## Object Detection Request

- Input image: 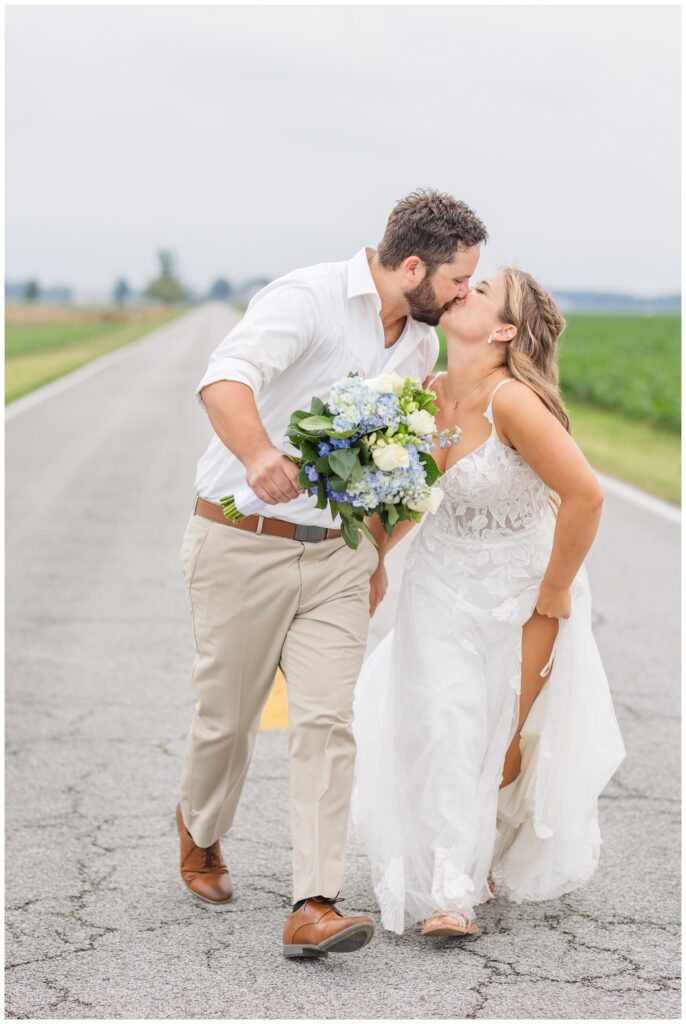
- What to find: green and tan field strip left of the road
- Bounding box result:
[5,305,182,402]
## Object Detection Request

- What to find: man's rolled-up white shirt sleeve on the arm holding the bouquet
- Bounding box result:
[196,279,324,402]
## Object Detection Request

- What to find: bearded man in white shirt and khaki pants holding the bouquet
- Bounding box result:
[176,190,486,956]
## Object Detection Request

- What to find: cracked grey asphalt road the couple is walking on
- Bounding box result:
[5,304,680,1019]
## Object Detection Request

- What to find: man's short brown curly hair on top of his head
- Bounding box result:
[378,188,488,274]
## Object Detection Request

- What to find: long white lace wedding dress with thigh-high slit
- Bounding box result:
[352,381,625,933]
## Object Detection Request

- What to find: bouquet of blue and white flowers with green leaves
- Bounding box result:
[221,373,461,548]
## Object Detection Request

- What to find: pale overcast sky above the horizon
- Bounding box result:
[6,6,680,294]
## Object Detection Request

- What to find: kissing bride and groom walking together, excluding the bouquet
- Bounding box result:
[176,190,625,957]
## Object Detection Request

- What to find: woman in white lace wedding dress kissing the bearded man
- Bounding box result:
[352,269,625,935]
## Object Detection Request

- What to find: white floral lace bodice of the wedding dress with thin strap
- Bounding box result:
[424,380,552,541]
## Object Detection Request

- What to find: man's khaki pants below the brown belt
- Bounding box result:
[181,515,378,900]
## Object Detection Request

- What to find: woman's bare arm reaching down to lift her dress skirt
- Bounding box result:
[494,381,603,618]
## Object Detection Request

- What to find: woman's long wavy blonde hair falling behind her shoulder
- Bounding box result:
[500,267,569,431]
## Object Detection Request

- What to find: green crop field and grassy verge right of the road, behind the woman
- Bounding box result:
[438,313,681,503]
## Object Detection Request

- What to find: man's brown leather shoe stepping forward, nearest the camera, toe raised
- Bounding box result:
[284,896,374,956]
